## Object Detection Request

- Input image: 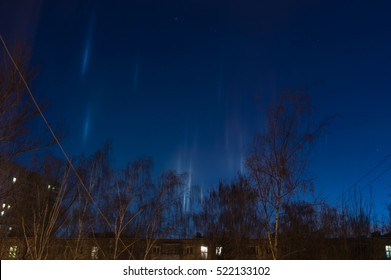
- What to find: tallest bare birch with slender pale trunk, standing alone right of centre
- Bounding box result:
[246,93,325,259]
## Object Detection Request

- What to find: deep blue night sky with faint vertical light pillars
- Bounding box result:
[0,0,391,217]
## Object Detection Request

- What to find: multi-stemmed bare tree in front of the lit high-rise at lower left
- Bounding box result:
[1,154,69,259]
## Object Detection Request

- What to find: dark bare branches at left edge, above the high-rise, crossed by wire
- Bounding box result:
[0,42,47,161]
